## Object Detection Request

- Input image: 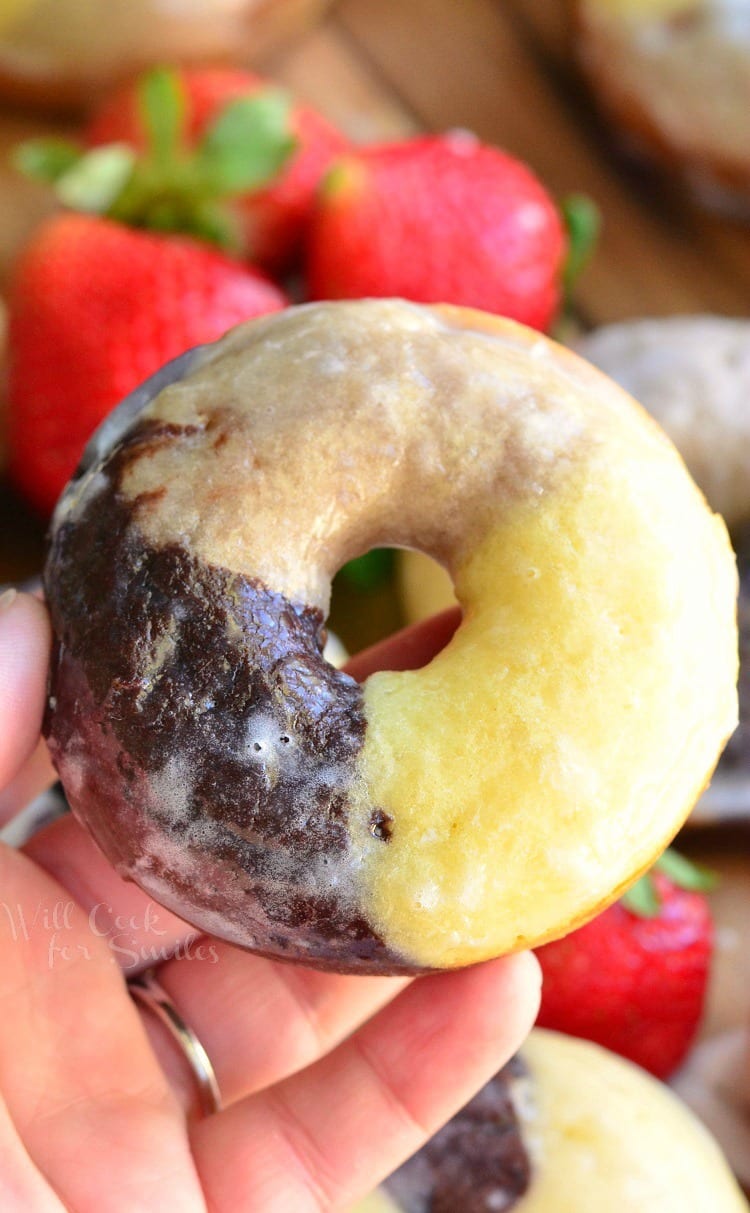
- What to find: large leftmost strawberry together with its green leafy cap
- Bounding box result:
[8,70,294,513]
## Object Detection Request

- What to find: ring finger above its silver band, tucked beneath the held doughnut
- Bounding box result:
[142,939,407,1106]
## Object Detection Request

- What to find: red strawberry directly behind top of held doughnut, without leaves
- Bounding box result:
[307,131,568,329]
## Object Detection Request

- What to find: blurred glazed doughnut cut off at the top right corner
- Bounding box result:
[572,0,750,216]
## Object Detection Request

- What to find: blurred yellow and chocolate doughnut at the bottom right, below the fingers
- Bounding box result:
[351,1029,748,1213]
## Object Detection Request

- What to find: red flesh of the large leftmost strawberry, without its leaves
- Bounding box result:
[8,215,286,513]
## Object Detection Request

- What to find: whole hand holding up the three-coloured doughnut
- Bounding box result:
[0,594,539,1213]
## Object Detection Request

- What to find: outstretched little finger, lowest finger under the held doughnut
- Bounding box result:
[193,955,540,1213]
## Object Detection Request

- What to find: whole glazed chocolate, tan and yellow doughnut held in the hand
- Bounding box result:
[45,300,737,973]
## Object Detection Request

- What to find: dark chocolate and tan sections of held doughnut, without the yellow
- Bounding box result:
[46,302,578,973]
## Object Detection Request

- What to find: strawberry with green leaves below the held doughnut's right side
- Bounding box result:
[536,850,712,1078]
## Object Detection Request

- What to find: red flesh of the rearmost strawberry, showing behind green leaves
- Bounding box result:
[86,68,348,269]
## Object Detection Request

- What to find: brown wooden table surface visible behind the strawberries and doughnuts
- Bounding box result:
[0,0,750,1164]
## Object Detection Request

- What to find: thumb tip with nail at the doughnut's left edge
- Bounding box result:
[0,590,51,787]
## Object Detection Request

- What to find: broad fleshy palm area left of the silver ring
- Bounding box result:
[0,847,205,1213]
